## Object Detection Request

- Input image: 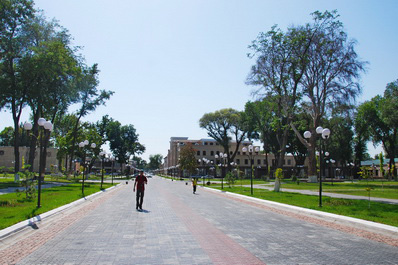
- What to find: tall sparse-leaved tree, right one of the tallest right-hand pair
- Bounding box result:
[291,11,366,176]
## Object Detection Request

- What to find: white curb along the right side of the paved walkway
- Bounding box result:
[202,187,398,235]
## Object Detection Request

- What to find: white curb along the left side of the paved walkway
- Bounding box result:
[0,183,122,240]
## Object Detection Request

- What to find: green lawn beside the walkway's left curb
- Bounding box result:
[0,183,116,229]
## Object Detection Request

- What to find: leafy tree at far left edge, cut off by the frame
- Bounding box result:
[0,0,34,173]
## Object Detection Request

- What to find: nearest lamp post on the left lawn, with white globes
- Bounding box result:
[23,118,53,208]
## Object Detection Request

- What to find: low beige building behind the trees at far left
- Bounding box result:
[0,146,58,173]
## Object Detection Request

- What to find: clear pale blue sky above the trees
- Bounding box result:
[0,0,398,159]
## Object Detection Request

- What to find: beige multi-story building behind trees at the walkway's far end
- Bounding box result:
[164,137,295,176]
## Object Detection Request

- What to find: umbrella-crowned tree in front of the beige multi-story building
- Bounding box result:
[199,108,248,172]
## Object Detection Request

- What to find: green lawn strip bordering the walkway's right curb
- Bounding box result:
[211,186,398,226]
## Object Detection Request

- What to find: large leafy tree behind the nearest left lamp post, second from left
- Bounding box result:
[20,14,80,171]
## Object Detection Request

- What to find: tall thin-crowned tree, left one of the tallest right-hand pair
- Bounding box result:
[246,20,313,167]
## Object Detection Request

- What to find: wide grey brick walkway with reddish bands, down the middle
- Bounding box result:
[0,175,398,264]
